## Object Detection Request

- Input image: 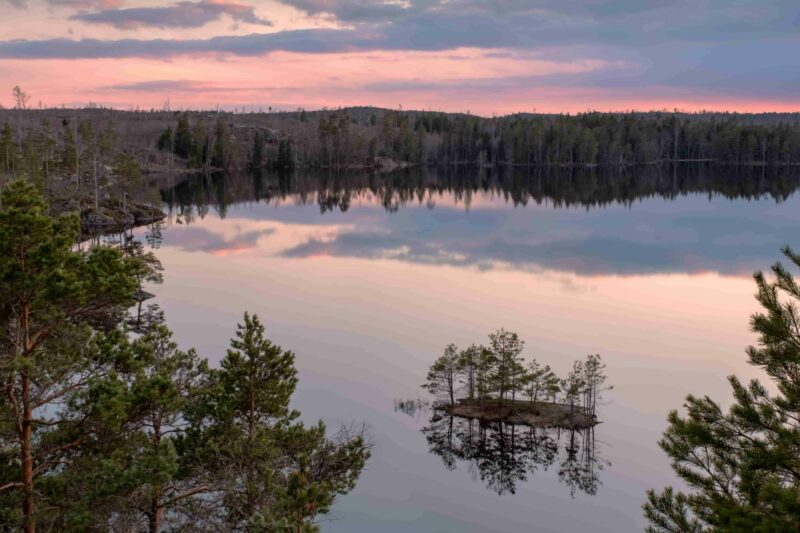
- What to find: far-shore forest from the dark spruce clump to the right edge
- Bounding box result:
[141,105,800,169]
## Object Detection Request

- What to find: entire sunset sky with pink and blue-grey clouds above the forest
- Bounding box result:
[0,0,800,116]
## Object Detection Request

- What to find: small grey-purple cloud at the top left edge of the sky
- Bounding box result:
[70,0,271,30]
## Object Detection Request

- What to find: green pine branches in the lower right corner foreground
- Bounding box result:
[644,248,800,533]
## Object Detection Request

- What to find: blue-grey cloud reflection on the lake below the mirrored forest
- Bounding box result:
[161,168,800,276]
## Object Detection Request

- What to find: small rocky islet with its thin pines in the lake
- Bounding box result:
[422,329,611,429]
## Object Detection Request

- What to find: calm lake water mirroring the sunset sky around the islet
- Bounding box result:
[142,169,800,533]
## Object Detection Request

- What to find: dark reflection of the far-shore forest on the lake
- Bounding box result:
[163,165,800,218]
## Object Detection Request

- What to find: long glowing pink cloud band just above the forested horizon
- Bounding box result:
[0,48,800,115]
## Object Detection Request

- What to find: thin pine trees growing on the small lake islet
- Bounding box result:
[423,329,608,419]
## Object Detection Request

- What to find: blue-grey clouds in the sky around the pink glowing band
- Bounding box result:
[0,0,800,103]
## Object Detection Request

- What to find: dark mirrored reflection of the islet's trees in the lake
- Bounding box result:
[422,413,609,498]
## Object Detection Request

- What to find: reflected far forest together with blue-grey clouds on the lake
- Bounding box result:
[156,166,800,276]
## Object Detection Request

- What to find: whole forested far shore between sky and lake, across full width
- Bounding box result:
[9,96,800,180]
